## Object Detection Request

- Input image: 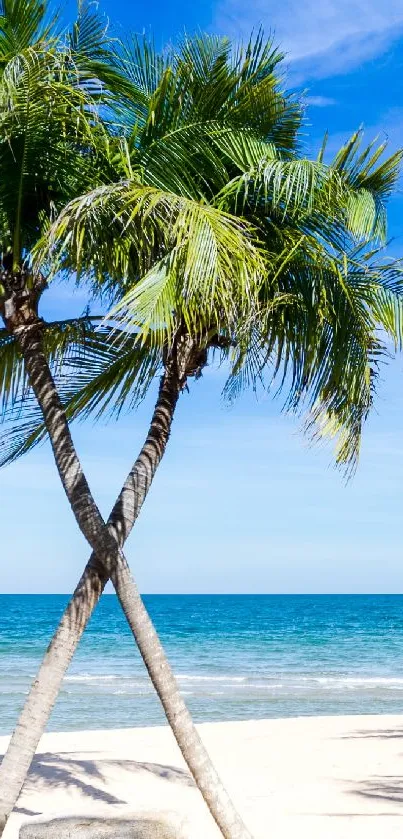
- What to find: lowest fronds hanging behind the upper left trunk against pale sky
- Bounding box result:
[0,319,162,466]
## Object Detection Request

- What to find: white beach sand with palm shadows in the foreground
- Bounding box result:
[0,715,403,839]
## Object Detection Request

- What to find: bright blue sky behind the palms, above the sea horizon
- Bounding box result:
[0,0,403,592]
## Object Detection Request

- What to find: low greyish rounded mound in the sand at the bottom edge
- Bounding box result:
[19,817,181,839]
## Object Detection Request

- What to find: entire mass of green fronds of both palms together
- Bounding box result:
[0,8,402,472]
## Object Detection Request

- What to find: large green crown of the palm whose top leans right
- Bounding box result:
[4,26,402,472]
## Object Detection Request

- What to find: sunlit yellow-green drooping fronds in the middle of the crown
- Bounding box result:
[38,181,265,343]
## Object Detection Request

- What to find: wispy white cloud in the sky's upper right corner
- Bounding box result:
[214,0,403,79]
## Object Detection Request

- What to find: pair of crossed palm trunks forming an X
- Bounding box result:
[0,320,251,839]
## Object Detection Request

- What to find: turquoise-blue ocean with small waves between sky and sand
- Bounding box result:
[0,595,403,734]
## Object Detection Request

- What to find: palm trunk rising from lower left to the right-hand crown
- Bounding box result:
[0,352,179,836]
